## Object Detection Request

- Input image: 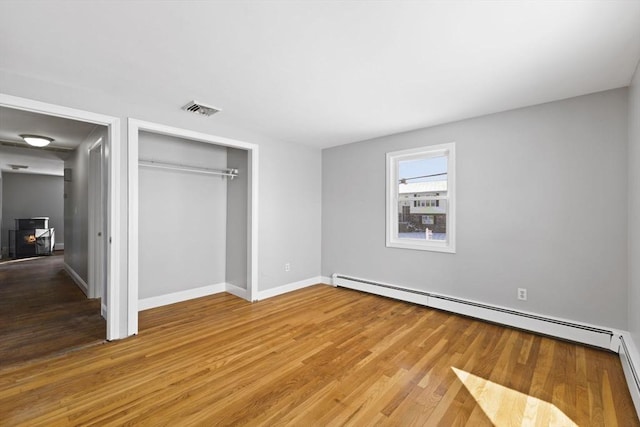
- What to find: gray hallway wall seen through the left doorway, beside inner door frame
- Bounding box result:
[64,126,107,282]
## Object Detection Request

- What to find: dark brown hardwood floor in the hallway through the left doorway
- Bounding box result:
[0,254,106,368]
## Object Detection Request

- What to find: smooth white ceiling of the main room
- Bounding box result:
[0,0,640,147]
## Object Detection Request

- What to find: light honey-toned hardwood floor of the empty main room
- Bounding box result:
[0,285,640,426]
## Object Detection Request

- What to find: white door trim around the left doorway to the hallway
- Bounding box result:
[0,93,126,340]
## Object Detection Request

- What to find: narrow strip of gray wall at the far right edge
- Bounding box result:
[628,68,640,348]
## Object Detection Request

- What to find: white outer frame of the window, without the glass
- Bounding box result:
[386,142,456,253]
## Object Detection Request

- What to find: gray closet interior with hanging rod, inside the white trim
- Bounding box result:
[138,131,248,301]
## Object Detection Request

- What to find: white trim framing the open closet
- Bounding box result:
[127,118,258,335]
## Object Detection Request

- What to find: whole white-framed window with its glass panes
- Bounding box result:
[387,143,455,253]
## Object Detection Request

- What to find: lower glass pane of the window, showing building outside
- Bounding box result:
[398,199,447,240]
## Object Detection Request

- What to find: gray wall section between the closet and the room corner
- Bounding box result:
[258,139,322,290]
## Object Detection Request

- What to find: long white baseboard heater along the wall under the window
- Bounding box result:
[331,274,619,352]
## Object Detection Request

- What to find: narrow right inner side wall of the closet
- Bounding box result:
[226,148,249,289]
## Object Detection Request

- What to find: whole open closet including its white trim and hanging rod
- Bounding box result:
[128,119,258,335]
